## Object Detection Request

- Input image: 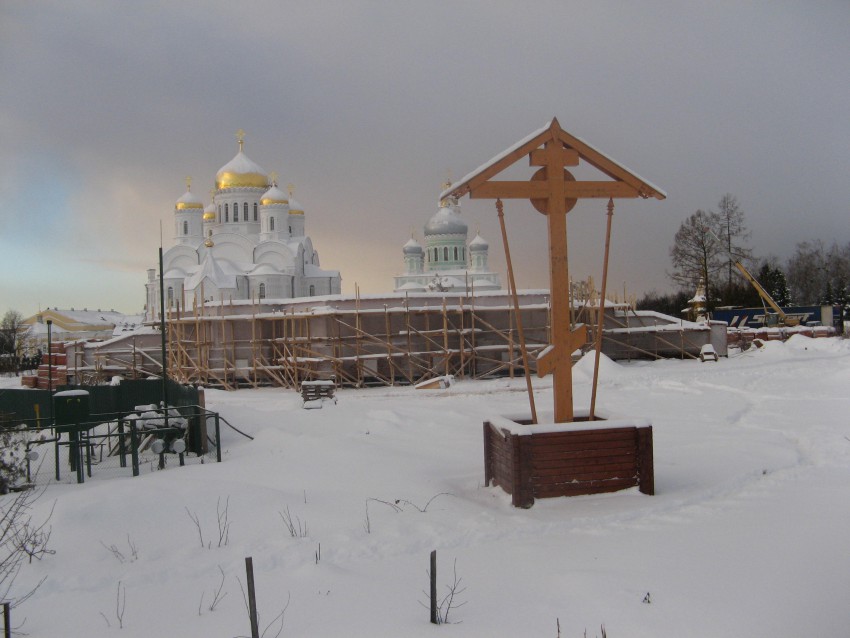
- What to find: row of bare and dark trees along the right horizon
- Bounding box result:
[638,193,850,316]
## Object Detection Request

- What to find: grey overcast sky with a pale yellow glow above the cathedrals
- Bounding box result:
[0,0,850,315]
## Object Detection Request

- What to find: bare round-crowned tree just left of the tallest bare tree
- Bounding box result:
[670,210,725,309]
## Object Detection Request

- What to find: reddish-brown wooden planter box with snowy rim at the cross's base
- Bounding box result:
[484,419,655,508]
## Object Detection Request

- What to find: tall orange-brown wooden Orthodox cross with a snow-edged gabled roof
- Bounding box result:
[440,119,667,423]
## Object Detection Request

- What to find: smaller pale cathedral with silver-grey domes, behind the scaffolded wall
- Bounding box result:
[395,183,502,294]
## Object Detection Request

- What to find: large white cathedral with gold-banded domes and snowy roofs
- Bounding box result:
[145,131,341,321]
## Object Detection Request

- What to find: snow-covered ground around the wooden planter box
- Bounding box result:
[3,336,850,638]
